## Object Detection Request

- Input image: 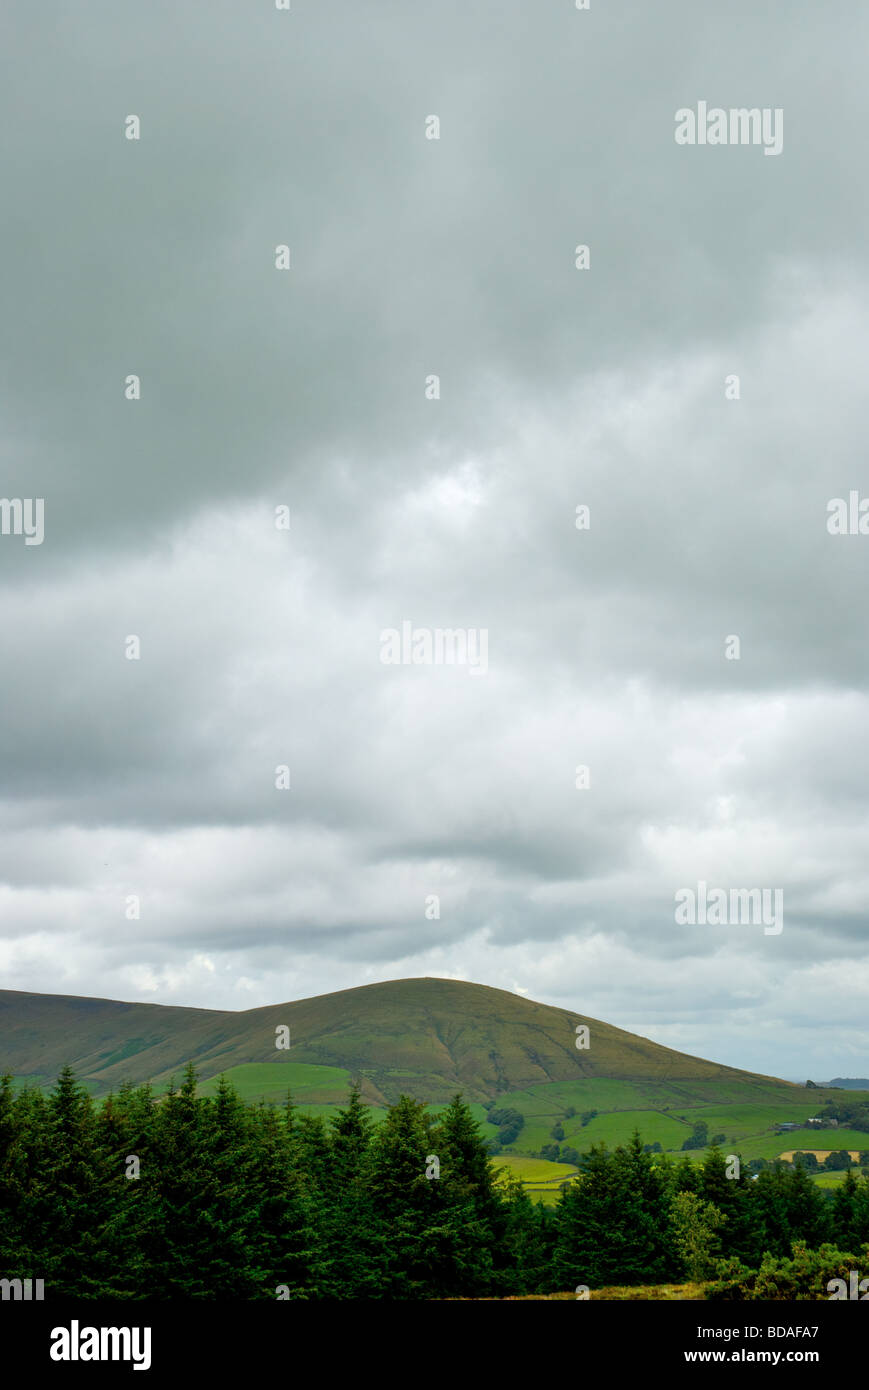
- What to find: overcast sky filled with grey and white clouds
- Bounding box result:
[0,0,869,1080]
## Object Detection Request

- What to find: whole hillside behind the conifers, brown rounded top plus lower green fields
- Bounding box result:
[0,979,869,1201]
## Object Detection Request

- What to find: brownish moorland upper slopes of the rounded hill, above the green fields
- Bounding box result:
[0,977,800,1104]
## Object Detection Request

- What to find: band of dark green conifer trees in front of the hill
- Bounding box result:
[0,1066,869,1300]
